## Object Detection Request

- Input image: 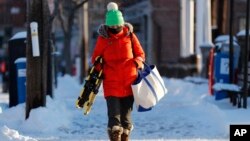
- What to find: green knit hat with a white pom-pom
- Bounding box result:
[105,2,124,26]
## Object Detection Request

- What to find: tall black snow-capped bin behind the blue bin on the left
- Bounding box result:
[8,31,27,107]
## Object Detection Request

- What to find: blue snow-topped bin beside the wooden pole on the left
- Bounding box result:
[15,57,26,104]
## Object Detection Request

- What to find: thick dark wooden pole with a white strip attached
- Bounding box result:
[26,0,50,119]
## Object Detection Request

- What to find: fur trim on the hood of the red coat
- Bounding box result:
[97,23,133,38]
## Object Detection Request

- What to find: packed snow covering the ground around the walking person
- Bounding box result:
[0,75,250,141]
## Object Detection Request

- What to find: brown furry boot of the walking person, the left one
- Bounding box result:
[108,126,123,141]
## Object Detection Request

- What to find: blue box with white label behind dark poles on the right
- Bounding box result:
[214,41,240,100]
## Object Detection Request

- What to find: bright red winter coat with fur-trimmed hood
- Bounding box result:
[92,23,145,97]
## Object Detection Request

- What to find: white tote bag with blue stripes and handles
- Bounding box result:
[131,62,167,112]
